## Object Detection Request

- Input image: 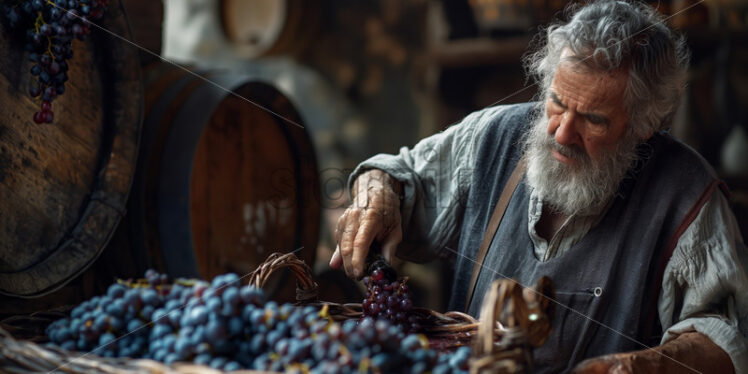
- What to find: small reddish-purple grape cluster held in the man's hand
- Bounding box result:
[361,268,421,332]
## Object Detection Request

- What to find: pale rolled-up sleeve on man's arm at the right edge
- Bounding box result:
[659,191,748,373]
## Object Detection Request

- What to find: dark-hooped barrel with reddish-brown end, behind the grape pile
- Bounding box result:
[128,64,320,288]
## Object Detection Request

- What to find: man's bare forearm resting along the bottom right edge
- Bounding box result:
[572,332,734,374]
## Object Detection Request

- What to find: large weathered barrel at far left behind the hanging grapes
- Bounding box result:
[0,0,142,298]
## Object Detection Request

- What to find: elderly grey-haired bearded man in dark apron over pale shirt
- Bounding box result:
[330,1,748,373]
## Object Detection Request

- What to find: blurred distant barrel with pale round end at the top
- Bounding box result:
[220,0,321,58]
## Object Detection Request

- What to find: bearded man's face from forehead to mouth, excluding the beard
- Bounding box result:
[545,62,628,167]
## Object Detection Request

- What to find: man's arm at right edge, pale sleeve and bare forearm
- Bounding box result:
[579,190,748,374]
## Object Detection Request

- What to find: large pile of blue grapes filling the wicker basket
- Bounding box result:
[47,271,470,374]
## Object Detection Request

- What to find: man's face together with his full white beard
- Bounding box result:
[525,57,640,215]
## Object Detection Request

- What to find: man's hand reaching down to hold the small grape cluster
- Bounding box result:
[330,169,403,279]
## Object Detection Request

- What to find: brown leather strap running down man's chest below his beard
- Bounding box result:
[465,158,525,311]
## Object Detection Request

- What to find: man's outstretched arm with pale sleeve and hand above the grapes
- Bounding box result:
[330,107,503,278]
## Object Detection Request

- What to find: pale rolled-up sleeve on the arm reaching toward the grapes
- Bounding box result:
[348,107,504,262]
